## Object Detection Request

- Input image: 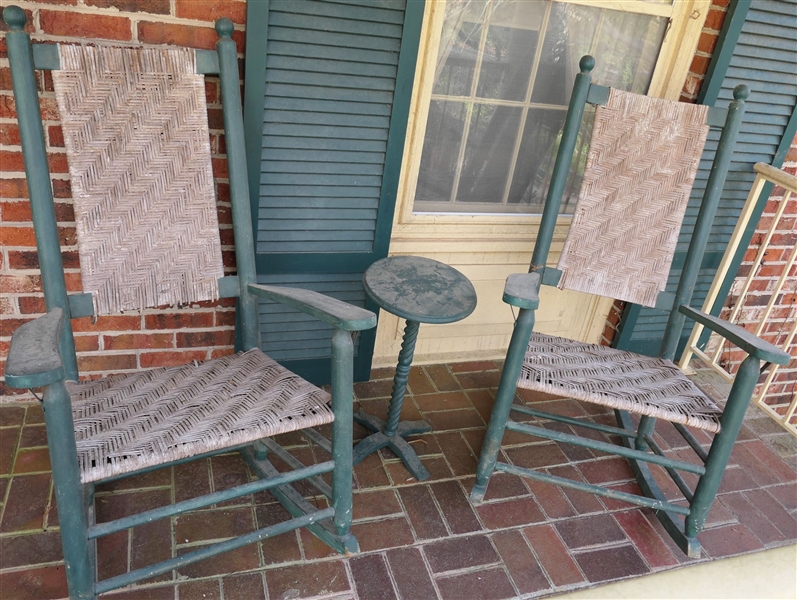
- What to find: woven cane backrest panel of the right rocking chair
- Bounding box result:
[558,89,708,307]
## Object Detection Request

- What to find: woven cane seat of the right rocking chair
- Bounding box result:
[518,333,722,433]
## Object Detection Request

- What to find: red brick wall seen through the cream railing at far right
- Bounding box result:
[712,136,797,412]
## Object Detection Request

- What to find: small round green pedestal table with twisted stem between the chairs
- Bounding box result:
[354,256,476,481]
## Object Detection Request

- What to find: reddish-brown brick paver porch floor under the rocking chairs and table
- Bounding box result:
[0,361,797,600]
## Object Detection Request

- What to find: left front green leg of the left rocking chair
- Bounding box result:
[44,381,95,599]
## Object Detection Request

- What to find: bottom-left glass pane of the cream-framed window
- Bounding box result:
[415,100,467,202]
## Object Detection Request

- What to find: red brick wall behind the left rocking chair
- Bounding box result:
[0,0,246,400]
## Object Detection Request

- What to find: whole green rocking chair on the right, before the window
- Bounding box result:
[471,56,789,557]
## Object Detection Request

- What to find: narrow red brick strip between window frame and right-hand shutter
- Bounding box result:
[601,0,731,346]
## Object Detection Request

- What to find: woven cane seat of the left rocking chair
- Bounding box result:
[63,349,333,483]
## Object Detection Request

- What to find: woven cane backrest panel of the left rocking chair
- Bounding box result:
[53,45,223,314]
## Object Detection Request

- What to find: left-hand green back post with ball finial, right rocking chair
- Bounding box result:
[529,55,595,272]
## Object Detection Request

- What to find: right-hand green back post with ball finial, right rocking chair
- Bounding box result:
[659,84,750,360]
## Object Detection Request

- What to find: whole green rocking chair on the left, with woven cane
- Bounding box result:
[3,6,376,598]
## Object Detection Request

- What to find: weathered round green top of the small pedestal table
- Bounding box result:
[363,256,476,323]
